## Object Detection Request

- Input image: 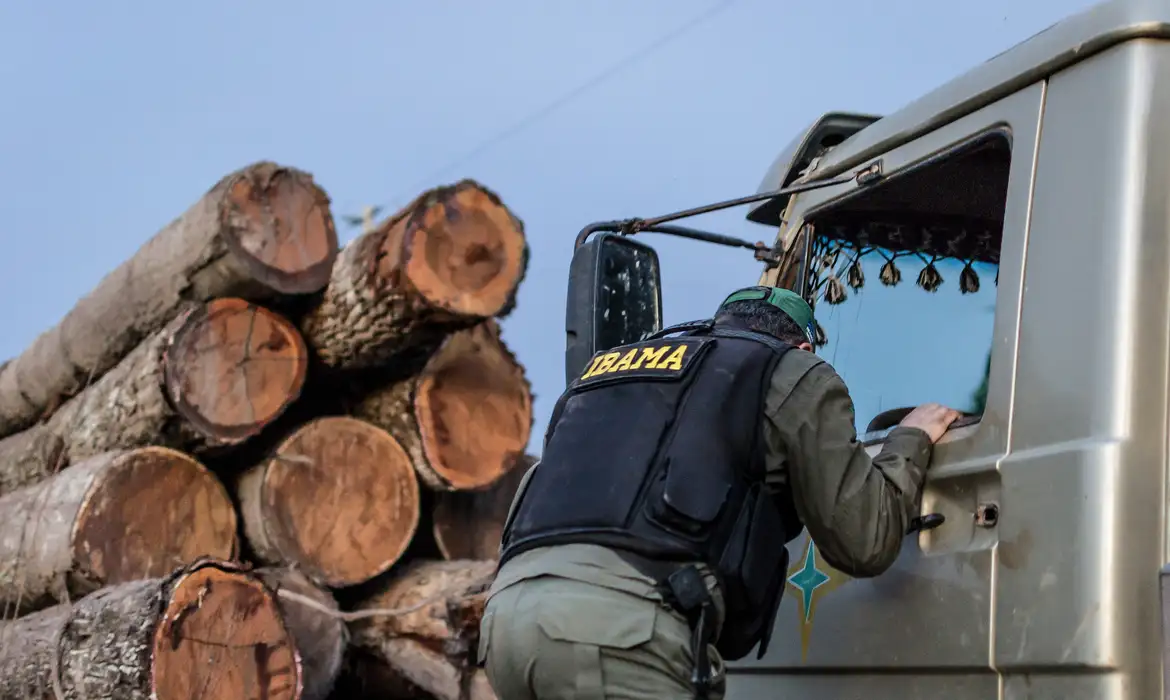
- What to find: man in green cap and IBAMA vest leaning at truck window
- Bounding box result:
[479,287,958,700]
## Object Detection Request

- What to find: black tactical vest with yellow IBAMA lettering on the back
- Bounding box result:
[500,322,801,659]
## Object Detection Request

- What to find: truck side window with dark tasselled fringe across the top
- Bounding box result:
[805,131,1011,433]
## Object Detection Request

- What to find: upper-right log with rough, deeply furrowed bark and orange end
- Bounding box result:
[301,180,528,369]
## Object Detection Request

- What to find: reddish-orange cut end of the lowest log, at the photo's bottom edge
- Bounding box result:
[151,567,302,700]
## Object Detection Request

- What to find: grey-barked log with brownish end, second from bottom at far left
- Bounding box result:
[0,447,236,615]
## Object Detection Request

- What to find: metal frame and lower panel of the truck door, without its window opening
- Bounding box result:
[731,84,1044,683]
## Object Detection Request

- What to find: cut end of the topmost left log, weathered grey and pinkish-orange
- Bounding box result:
[220,163,338,294]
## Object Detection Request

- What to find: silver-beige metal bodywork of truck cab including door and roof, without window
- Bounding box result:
[728,0,1170,700]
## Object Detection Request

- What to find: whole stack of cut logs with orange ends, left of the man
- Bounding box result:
[0,162,532,700]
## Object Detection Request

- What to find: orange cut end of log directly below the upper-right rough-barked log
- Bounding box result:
[414,322,532,490]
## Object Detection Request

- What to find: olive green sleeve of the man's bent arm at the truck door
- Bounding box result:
[764,354,932,578]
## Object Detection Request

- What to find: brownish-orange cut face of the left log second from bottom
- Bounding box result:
[73,447,236,584]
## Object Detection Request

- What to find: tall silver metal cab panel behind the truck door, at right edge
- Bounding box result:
[993,40,1170,699]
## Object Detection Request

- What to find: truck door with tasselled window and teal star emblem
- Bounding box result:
[728,83,1045,700]
